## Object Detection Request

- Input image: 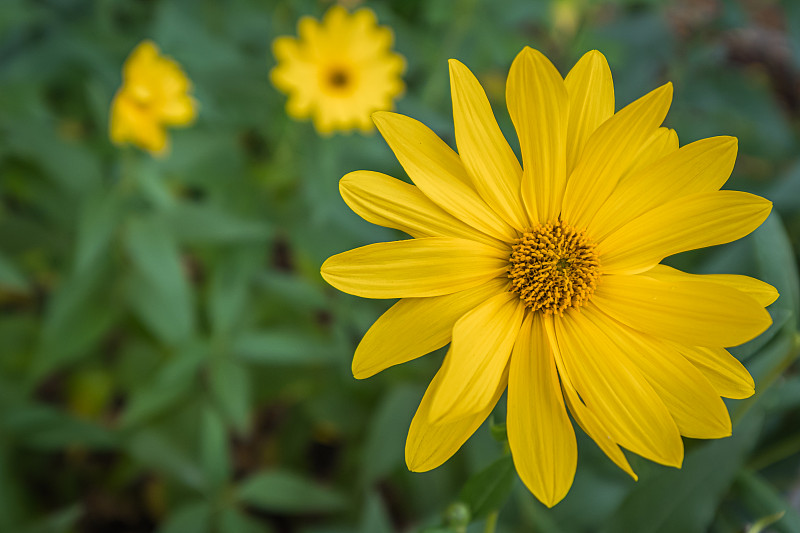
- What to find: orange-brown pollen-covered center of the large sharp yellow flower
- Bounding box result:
[508,220,600,315]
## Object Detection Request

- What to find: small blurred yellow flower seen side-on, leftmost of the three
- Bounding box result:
[110,41,197,155]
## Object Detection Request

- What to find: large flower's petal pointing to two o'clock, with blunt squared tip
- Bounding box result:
[589,137,736,240]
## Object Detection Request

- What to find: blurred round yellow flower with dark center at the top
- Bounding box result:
[270,6,405,134]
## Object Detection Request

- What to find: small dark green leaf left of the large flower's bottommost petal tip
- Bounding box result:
[458,455,516,520]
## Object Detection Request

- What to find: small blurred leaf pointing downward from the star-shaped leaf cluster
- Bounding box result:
[208,356,252,434]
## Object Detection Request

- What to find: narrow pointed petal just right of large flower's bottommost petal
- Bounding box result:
[542,315,639,479]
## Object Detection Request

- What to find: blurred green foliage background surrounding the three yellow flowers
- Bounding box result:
[0,0,800,533]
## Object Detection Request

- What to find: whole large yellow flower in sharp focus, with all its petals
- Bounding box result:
[322,48,777,506]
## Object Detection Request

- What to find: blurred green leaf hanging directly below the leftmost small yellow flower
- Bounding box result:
[125,216,195,344]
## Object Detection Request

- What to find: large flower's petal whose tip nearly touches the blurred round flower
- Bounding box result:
[372,111,516,241]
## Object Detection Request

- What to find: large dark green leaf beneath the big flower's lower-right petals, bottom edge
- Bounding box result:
[602,411,763,533]
